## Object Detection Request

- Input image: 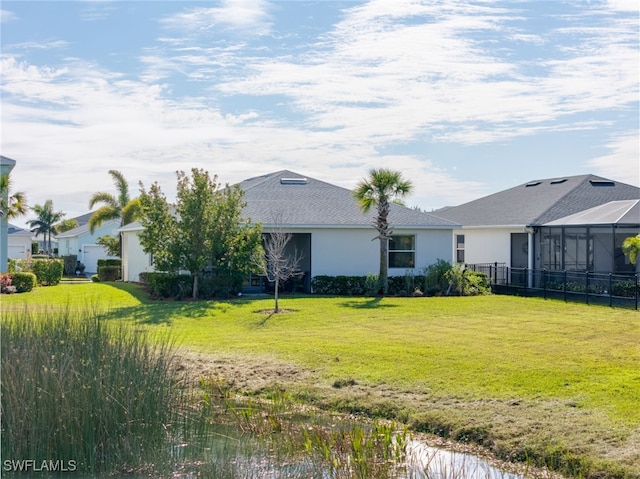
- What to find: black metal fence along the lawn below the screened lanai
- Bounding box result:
[467,263,640,310]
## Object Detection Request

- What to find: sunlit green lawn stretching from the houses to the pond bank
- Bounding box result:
[0,283,640,477]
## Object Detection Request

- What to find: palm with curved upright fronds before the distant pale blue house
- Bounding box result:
[89,170,140,257]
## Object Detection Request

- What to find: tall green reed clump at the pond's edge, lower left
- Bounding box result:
[0,310,188,473]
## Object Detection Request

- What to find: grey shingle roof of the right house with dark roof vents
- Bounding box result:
[437,175,640,226]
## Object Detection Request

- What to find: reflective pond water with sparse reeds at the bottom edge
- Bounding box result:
[159,408,524,479]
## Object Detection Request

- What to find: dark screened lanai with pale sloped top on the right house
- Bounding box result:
[536,200,640,274]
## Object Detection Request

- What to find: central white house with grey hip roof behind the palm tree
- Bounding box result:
[120,170,459,290]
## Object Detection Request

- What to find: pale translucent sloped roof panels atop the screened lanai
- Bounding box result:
[544,199,640,226]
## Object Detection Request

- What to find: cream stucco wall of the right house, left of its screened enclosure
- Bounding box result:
[453,227,525,267]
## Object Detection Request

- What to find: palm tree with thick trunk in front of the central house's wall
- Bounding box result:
[353,168,413,294]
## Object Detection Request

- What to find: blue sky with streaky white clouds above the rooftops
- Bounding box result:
[0,0,640,229]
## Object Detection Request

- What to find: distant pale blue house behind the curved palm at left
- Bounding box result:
[58,215,120,274]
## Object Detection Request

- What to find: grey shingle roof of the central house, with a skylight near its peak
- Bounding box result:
[238,170,459,229]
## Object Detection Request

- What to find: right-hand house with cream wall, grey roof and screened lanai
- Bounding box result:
[435,175,640,273]
